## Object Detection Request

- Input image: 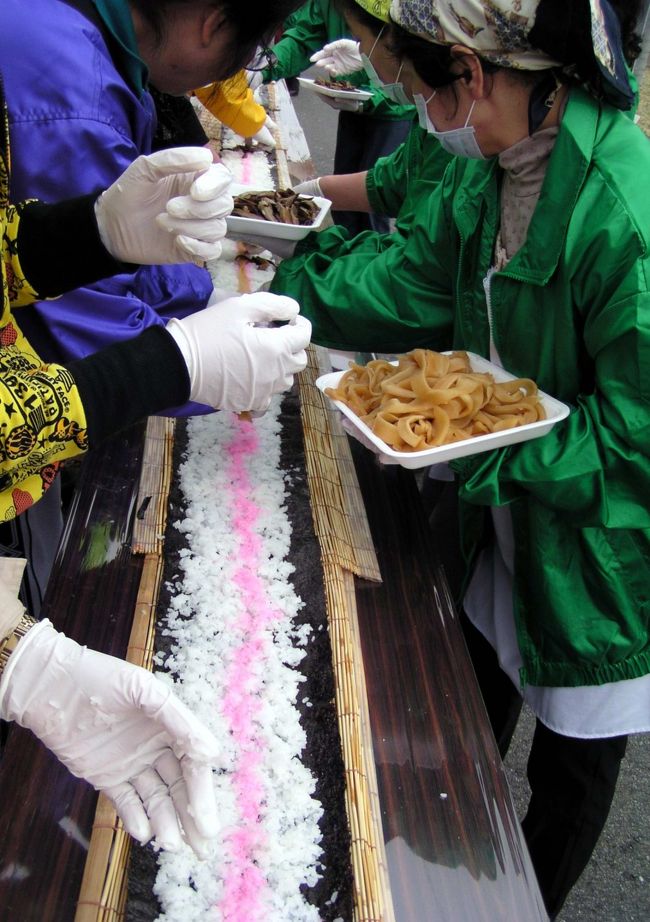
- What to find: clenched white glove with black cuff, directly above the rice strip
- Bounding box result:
[167,292,311,413]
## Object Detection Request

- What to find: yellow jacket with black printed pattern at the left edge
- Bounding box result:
[0,90,87,520]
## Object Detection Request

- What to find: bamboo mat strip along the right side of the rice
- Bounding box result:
[300,346,395,922]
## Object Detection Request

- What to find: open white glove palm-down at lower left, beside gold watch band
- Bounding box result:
[0,621,219,857]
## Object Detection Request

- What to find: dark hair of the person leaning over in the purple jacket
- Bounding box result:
[130,0,301,80]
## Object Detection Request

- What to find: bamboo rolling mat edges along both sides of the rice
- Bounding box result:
[75,93,395,922]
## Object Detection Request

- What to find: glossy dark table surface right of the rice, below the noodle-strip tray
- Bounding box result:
[346,446,547,922]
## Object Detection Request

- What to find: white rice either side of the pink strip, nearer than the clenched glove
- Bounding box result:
[154,397,321,922]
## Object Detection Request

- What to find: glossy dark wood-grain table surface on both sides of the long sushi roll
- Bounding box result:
[0,418,546,922]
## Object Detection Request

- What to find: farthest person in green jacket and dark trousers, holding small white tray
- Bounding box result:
[253,0,414,234]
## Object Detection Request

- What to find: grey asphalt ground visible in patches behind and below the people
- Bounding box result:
[293,71,650,922]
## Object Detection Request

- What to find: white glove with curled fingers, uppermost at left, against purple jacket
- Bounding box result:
[95,147,233,265]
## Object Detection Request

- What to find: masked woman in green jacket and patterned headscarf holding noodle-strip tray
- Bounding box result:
[275,0,650,917]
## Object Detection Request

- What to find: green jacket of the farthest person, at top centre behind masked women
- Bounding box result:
[262,0,408,121]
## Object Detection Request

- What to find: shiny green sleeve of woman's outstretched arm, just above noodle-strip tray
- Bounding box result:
[271,180,453,352]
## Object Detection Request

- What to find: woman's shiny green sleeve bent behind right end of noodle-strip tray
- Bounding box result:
[451,285,650,529]
